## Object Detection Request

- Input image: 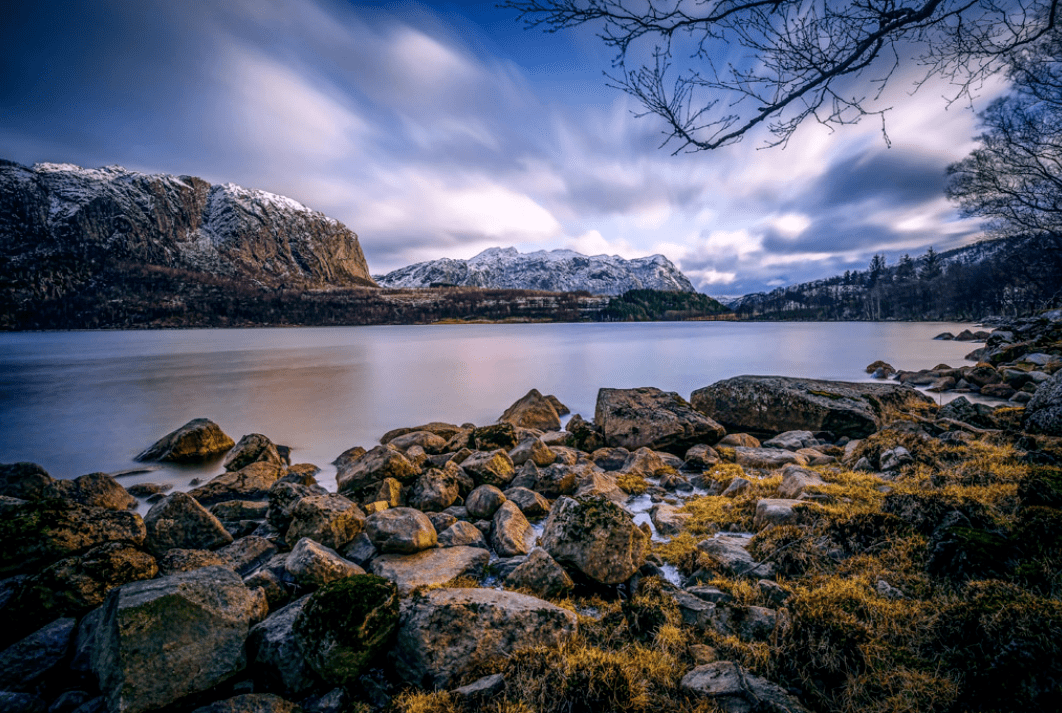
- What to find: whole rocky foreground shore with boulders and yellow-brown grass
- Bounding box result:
[0,315,1062,713]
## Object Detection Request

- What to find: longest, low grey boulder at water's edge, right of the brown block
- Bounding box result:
[690,376,933,438]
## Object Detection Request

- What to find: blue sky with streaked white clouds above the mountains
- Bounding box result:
[0,0,1001,296]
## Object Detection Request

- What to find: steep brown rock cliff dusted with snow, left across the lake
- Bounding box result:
[0,162,373,299]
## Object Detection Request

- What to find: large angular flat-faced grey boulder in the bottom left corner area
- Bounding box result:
[92,566,266,713]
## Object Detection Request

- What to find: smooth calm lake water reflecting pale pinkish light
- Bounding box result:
[0,322,976,497]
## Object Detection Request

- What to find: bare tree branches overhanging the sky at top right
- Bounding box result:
[501,0,1062,153]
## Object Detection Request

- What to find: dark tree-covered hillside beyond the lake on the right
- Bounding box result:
[735,235,1062,321]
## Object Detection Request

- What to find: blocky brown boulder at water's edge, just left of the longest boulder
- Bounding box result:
[594,387,726,455]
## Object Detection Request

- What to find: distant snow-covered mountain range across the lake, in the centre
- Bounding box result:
[374,248,696,294]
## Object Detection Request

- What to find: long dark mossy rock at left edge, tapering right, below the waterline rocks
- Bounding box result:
[0,499,147,575]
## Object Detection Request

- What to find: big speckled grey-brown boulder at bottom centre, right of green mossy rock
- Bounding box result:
[394,589,577,689]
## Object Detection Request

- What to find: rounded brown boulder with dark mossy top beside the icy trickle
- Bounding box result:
[542,497,649,584]
